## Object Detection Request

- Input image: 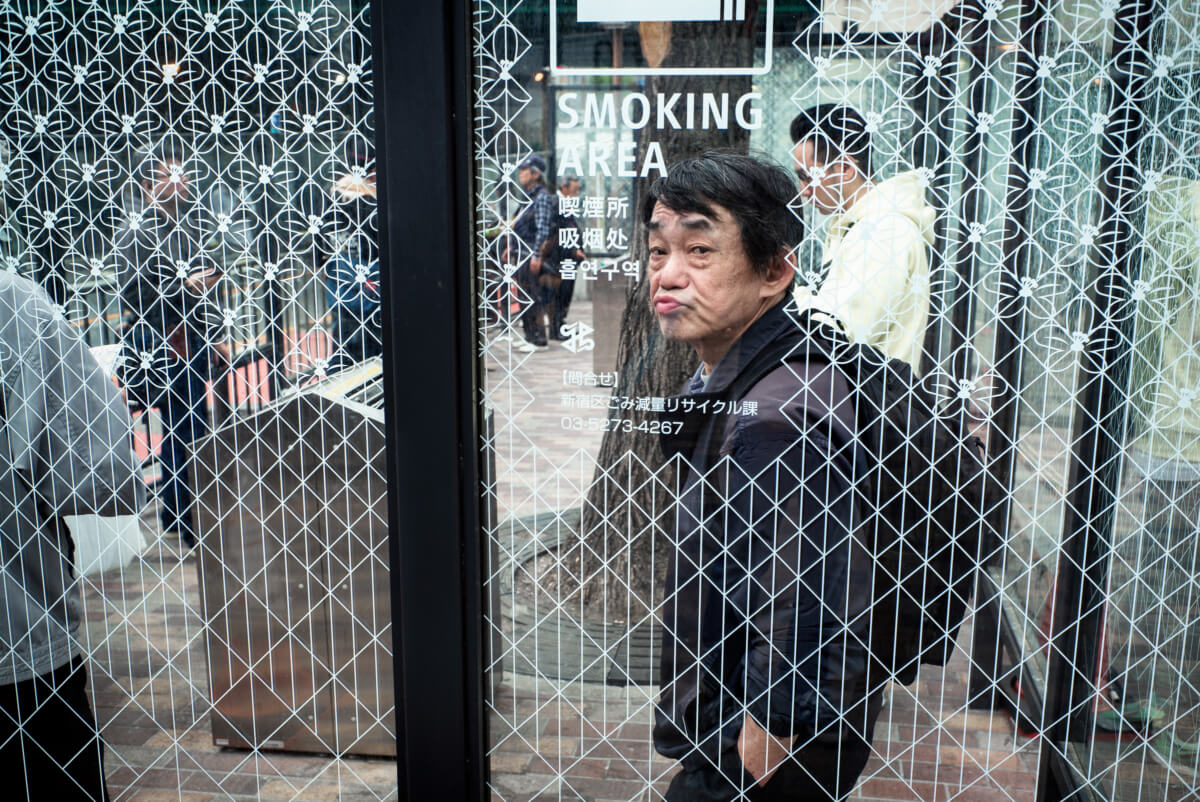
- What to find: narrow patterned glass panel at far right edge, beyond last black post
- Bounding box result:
[1084,2,1200,800]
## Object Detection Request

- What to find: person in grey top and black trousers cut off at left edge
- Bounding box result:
[0,267,145,800]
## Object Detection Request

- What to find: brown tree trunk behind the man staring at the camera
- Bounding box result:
[573,17,757,623]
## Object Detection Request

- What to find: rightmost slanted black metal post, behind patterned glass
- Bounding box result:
[1043,0,1157,768]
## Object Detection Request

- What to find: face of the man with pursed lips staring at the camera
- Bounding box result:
[649,203,778,365]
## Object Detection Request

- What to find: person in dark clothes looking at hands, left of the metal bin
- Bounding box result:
[119,145,229,549]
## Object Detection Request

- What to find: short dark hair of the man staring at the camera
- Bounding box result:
[642,152,804,275]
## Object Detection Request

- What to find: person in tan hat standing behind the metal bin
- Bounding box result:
[324,145,383,367]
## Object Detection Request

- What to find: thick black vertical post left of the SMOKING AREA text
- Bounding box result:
[371,0,486,802]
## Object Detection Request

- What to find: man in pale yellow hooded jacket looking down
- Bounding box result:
[791,103,936,373]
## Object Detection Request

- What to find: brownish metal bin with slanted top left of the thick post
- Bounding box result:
[191,359,396,755]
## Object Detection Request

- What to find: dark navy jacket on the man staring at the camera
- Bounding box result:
[654,301,871,765]
